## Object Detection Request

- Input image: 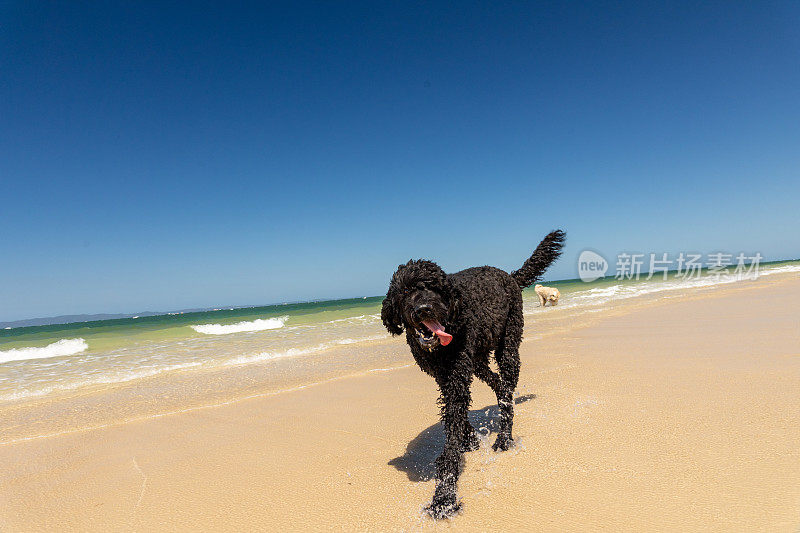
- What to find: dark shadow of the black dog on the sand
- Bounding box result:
[389,394,536,481]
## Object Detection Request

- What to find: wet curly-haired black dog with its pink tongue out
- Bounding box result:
[381,230,565,519]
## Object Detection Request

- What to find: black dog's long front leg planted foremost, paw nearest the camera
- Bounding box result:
[426,356,472,519]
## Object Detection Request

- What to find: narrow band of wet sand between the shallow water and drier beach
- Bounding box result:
[0,272,797,446]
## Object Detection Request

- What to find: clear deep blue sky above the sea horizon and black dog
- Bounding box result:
[0,2,800,320]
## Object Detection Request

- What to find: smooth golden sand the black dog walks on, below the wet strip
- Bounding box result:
[0,274,800,531]
